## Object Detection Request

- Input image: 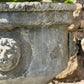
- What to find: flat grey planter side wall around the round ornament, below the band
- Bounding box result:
[0,25,68,84]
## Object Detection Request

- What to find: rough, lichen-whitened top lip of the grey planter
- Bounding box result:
[0,2,76,12]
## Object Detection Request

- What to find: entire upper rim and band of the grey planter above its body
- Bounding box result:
[0,2,76,29]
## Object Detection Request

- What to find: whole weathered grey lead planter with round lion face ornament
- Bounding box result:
[0,2,75,84]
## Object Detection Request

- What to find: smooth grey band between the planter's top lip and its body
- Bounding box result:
[0,11,73,30]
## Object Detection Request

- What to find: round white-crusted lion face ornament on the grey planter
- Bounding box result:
[0,38,20,71]
